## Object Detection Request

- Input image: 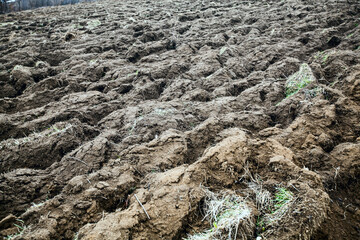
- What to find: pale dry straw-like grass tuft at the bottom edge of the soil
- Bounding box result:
[185,189,254,240]
